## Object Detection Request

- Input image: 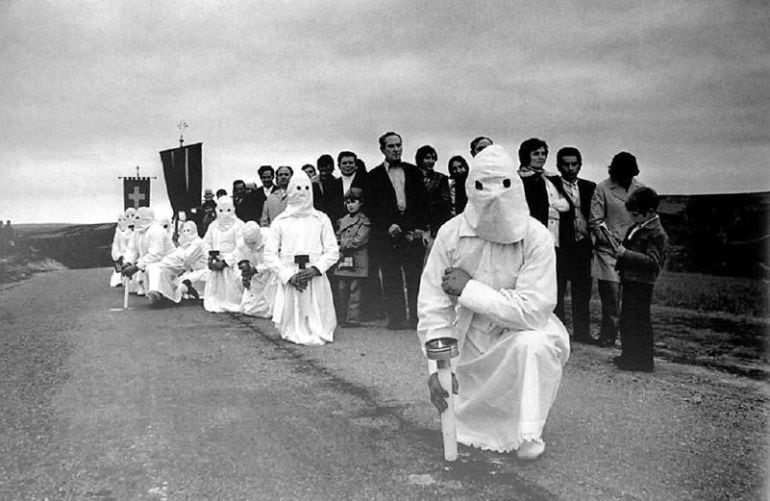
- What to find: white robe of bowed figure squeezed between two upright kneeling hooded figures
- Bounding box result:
[235,228,278,318]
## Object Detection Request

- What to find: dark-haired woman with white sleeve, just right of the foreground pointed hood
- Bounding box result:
[518,137,570,240]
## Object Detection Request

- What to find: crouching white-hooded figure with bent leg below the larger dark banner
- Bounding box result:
[147,221,208,303]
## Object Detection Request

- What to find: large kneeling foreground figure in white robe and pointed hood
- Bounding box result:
[417,145,570,460]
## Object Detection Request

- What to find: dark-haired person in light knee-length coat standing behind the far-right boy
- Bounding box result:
[588,151,643,346]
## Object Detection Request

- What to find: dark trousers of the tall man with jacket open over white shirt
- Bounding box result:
[377,238,425,325]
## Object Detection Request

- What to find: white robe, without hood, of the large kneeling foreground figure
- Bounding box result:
[417,215,570,452]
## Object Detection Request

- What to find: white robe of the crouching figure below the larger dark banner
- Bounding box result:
[146,237,209,303]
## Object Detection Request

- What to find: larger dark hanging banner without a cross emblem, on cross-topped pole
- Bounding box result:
[160,143,203,216]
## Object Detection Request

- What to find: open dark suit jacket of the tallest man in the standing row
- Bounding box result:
[366,162,428,234]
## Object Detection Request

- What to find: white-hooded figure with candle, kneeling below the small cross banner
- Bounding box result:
[123,207,176,296]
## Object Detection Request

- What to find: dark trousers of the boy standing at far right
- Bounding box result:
[620,282,653,369]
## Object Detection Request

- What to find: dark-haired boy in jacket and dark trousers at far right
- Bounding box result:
[614,187,668,372]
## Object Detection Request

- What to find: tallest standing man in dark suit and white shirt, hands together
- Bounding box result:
[365,132,428,330]
